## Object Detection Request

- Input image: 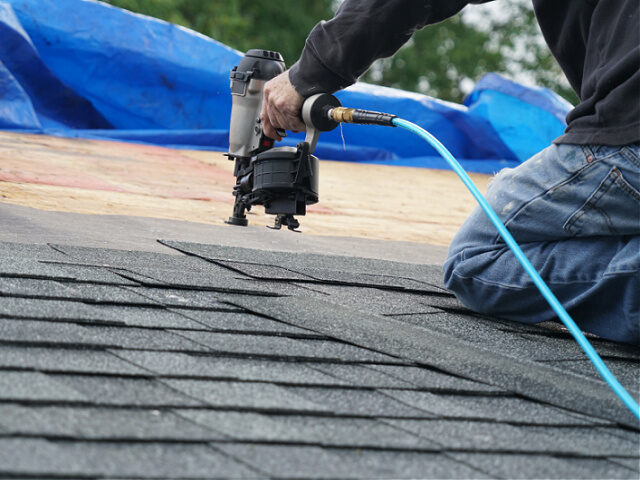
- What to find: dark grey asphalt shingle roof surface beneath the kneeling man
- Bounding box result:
[0,242,640,478]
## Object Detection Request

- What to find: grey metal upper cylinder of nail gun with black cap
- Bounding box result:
[229,49,285,158]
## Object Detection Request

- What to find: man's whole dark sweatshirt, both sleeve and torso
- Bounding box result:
[289,0,640,145]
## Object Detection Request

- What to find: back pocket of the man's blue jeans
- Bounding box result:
[563,167,640,236]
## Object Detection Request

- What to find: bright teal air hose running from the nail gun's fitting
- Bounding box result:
[390,116,640,420]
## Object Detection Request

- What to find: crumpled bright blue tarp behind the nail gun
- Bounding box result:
[0,0,571,173]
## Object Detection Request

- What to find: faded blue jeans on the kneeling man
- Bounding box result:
[444,143,640,344]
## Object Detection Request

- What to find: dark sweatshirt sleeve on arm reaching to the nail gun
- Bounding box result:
[289,0,487,97]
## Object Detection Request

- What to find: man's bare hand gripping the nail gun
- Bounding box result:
[260,70,306,140]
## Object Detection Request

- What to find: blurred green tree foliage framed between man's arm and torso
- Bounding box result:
[365,0,578,104]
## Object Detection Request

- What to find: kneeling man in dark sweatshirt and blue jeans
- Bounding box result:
[262,0,640,344]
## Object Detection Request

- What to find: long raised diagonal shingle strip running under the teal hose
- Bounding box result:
[228,297,638,428]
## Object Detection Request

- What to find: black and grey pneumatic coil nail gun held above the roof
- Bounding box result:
[226,50,340,230]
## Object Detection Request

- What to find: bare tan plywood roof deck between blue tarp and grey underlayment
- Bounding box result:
[0,132,490,246]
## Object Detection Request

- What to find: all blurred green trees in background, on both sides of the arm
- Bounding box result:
[106,0,577,104]
